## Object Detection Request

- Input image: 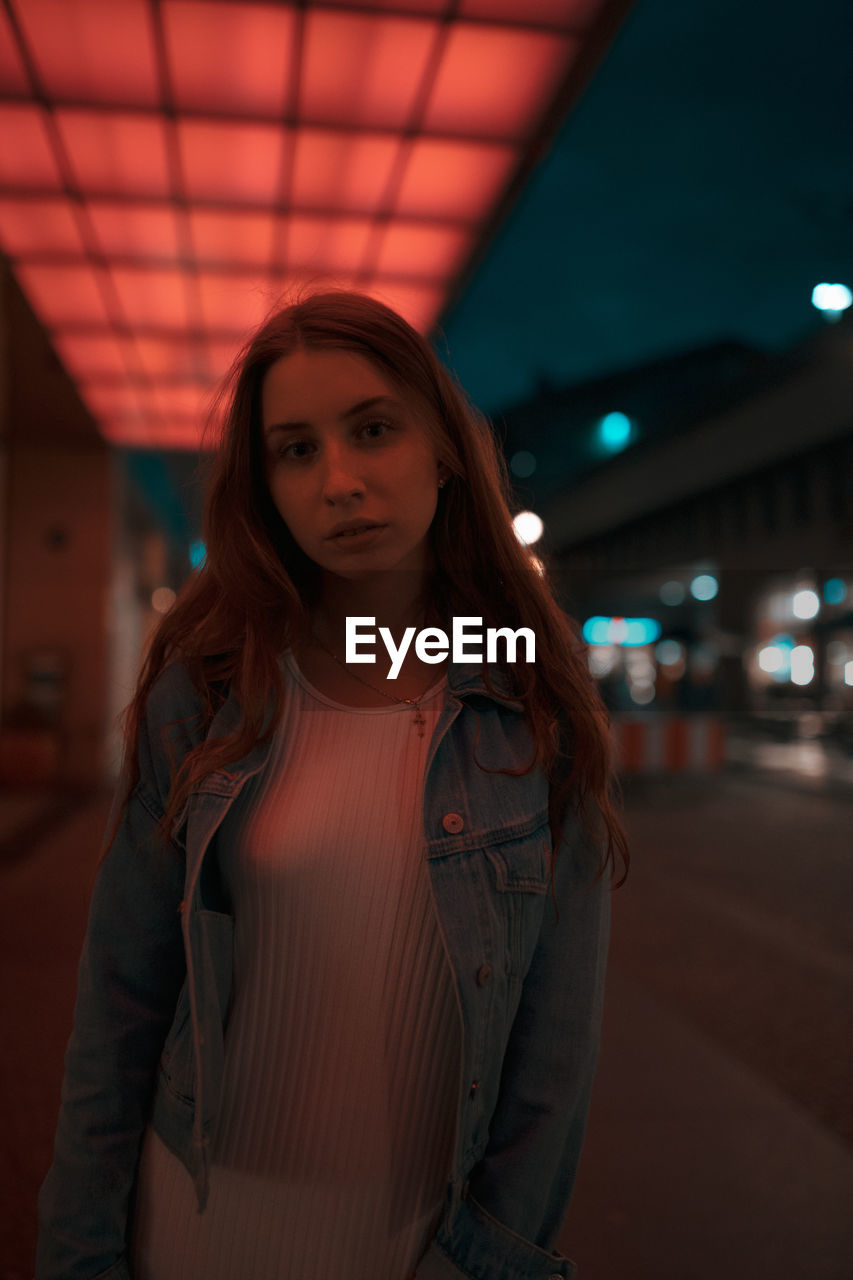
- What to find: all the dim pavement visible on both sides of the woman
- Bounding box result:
[0,756,853,1280]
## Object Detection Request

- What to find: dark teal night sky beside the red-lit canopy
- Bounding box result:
[437,0,853,412]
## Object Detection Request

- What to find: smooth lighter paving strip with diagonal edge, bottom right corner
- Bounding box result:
[557,965,853,1280]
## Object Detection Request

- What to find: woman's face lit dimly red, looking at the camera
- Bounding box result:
[261,348,439,579]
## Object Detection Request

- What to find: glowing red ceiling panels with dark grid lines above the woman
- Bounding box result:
[0,0,606,448]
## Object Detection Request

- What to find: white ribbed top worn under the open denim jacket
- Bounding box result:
[131,652,460,1280]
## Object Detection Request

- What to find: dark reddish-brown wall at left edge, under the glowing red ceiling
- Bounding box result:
[0,262,114,785]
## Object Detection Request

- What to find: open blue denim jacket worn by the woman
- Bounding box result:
[36,662,610,1280]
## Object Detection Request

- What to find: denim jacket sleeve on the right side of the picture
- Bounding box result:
[418,817,610,1280]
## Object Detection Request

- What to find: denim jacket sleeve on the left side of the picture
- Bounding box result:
[36,670,192,1280]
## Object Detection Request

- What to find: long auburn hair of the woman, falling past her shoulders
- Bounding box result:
[105,291,629,886]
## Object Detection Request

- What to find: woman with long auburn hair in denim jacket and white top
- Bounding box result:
[37,292,628,1280]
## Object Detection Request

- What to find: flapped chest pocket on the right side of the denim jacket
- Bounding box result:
[483,822,549,980]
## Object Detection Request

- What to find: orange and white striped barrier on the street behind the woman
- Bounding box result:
[611,716,726,773]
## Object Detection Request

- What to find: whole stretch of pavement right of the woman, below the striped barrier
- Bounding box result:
[558,771,853,1280]
